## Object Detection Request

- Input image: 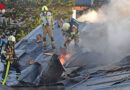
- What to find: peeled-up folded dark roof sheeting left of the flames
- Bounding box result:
[12,54,65,87]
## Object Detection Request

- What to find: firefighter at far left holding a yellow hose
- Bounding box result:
[1,36,21,85]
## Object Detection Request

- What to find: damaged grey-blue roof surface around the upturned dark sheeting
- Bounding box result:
[1,23,130,90]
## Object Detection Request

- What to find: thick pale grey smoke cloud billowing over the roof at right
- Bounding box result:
[78,0,130,63]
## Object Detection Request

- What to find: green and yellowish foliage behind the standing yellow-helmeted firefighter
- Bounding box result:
[2,0,75,41]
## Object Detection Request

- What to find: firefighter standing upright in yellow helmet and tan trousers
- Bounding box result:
[40,6,55,50]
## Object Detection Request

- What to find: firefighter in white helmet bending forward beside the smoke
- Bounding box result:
[62,20,80,48]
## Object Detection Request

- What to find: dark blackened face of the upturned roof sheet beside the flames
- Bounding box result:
[40,54,64,85]
